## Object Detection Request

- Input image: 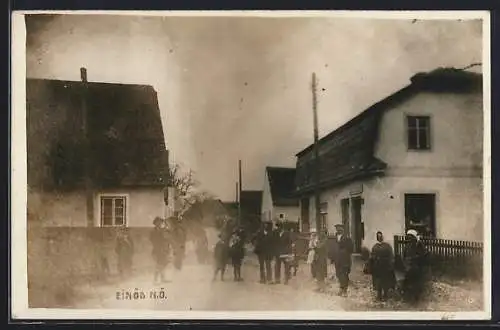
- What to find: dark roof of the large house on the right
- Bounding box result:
[295,68,482,195]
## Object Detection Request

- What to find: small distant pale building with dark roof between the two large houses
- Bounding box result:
[261,166,300,223]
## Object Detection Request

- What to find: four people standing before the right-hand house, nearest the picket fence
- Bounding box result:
[307,224,428,303]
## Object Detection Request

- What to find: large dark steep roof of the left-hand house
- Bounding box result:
[26,79,168,189]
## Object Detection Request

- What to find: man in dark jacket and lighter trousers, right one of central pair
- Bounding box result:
[273,222,292,284]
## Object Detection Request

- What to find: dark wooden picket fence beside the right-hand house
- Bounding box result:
[394,235,483,278]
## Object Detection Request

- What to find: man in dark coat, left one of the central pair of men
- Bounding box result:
[254,222,273,284]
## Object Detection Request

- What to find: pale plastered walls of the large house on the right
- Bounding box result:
[309,89,483,246]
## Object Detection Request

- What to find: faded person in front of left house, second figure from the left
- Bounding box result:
[149,217,170,283]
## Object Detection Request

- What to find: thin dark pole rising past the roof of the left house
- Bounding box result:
[80,68,94,227]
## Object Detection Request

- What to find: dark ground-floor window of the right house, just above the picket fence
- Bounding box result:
[405,194,436,237]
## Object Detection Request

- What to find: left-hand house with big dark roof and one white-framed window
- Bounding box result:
[26,79,169,227]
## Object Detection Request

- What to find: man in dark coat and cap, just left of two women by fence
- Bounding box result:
[333,224,353,297]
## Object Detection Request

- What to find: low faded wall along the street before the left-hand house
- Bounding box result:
[27,227,209,307]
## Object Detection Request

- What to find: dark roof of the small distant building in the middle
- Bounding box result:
[266,166,299,206]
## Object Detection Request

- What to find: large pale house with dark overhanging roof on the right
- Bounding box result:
[296,68,483,252]
